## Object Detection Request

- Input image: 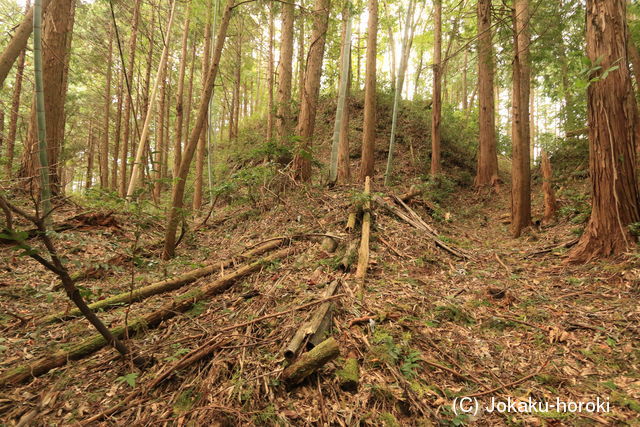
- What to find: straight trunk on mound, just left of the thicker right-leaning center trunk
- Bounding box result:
[276,2,296,145]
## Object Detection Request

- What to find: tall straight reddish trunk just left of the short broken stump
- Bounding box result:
[511,0,531,237]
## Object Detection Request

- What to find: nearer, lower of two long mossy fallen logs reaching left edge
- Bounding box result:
[0,247,297,386]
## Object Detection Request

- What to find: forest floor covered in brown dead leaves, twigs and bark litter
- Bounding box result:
[0,176,640,426]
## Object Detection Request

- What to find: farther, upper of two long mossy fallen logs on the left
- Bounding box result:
[39,239,285,324]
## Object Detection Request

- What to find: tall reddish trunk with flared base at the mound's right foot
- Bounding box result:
[475,0,499,187]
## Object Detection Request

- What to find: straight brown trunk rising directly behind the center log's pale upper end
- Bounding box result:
[358,0,378,182]
